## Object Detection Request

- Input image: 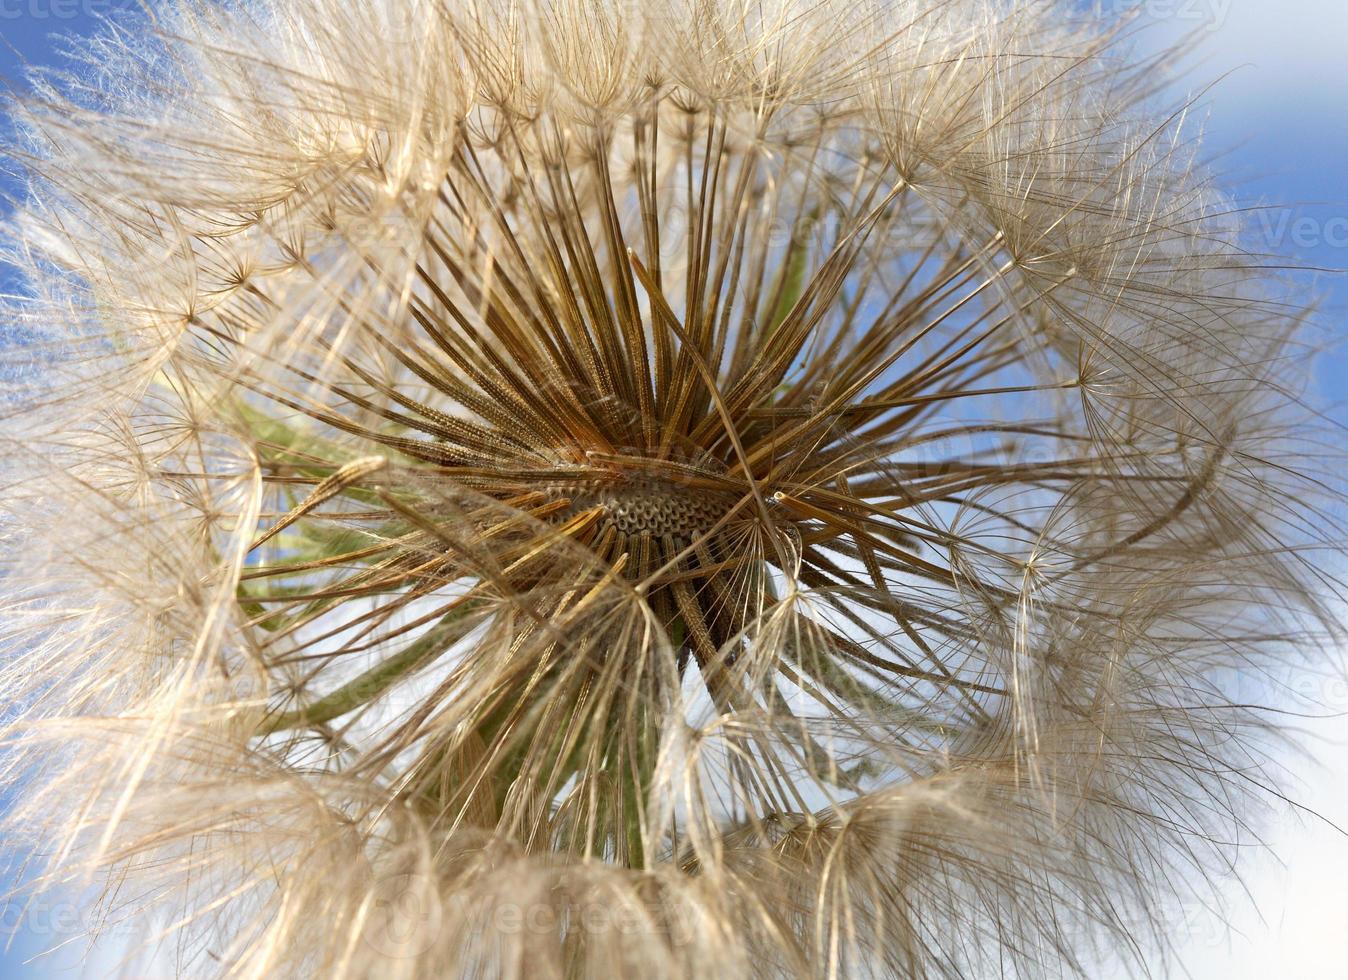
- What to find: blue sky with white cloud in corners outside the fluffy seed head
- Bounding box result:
[0,0,1348,980]
